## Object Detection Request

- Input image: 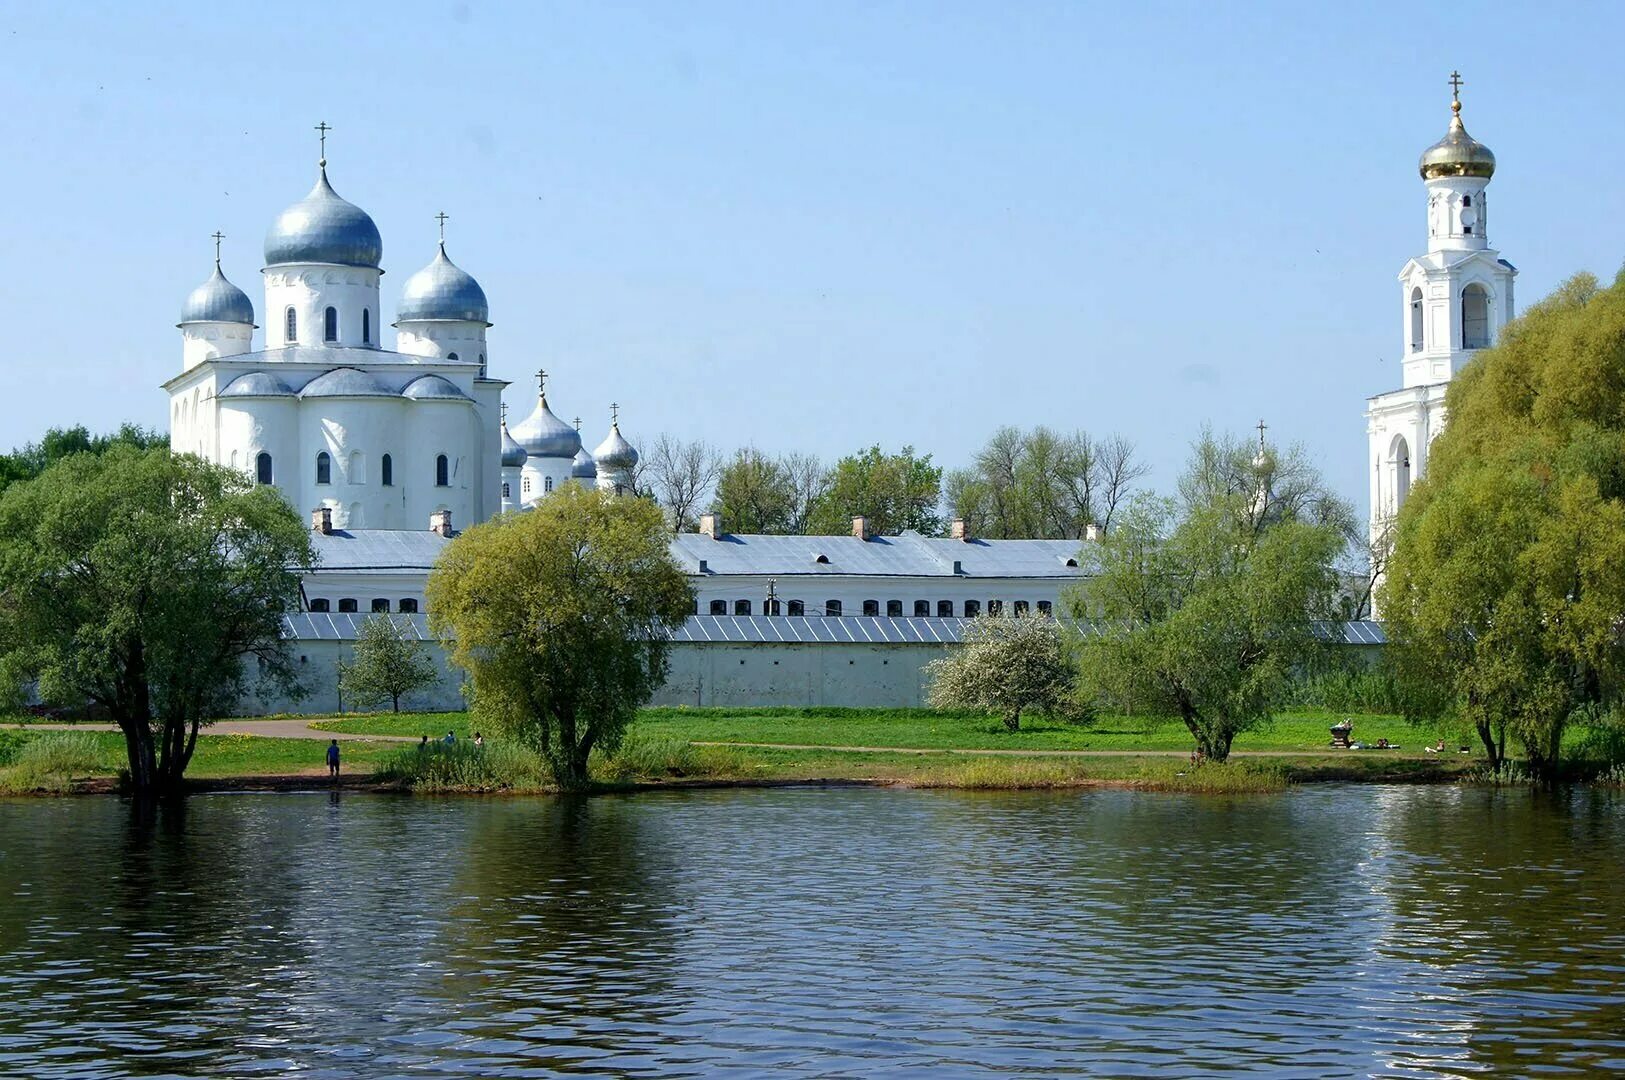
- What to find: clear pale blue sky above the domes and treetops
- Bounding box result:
[0,2,1625,522]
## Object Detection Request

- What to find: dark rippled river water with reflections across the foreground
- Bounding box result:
[0,788,1625,1077]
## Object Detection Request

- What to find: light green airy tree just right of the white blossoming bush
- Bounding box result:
[1073,434,1354,762]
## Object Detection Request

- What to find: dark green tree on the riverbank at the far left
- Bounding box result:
[0,445,314,791]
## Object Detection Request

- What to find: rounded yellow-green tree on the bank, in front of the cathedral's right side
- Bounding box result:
[427,484,694,788]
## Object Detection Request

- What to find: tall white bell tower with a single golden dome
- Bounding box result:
[1365,71,1518,547]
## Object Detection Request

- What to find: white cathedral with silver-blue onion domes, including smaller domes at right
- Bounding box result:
[164,142,637,534]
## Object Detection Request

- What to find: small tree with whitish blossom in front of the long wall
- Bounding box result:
[928,614,1074,731]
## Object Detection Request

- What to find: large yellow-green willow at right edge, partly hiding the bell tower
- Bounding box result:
[1378,274,1625,780]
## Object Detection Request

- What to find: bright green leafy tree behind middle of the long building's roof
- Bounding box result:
[809,447,943,536]
